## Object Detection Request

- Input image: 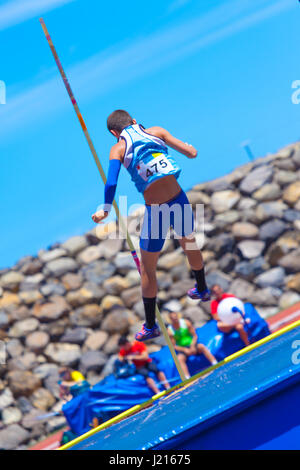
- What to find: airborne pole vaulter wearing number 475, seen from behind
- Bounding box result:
[92,110,210,341]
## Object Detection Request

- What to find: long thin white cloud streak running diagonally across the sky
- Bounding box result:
[0,0,294,139]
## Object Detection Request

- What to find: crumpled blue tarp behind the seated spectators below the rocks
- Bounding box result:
[62,303,270,435]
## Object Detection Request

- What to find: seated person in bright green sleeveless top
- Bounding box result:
[168,312,217,379]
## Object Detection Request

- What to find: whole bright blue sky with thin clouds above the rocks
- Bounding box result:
[0,0,300,268]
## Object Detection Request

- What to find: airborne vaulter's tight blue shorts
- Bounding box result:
[140,191,194,252]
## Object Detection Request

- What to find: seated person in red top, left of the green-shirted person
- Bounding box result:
[119,336,170,394]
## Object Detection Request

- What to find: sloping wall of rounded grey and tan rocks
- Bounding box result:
[0,143,300,449]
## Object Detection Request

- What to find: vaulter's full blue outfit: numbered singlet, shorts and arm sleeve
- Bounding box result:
[104,124,194,252]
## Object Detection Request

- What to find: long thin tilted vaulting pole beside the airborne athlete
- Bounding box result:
[40,18,185,381]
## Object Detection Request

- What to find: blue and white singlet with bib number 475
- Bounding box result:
[120,124,181,193]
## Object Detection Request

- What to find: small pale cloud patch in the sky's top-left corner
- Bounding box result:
[0,0,75,31]
